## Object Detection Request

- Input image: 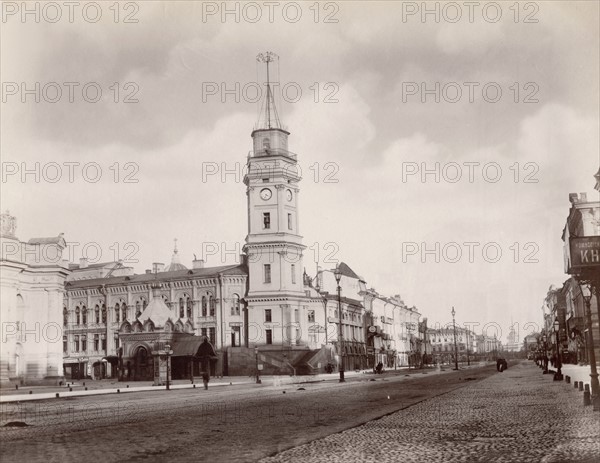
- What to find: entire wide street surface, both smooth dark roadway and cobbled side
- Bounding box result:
[0,362,600,463]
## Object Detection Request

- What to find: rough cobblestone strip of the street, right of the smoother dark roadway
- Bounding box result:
[261,362,600,463]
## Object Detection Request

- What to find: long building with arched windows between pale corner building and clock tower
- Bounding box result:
[62,249,248,379]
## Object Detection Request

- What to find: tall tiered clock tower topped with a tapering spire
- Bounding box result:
[244,52,309,347]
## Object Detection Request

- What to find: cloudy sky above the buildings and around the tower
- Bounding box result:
[1,2,600,339]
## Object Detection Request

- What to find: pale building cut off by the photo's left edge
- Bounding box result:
[0,211,69,385]
